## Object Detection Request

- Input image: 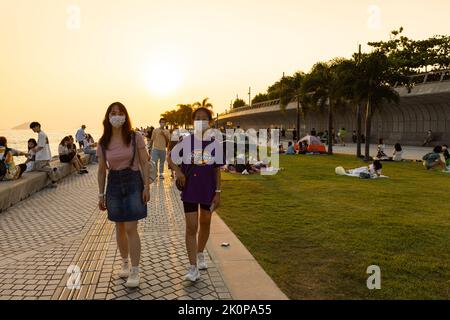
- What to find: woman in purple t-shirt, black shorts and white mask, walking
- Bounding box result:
[168,107,223,282]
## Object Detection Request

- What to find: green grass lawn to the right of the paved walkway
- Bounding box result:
[219,155,450,299]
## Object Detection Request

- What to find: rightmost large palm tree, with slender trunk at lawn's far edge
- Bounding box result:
[355,51,404,161]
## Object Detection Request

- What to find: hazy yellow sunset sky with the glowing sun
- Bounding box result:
[0,0,450,129]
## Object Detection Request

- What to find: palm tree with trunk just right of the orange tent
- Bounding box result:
[301,59,343,154]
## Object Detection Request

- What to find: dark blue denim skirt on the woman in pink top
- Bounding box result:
[106,169,147,222]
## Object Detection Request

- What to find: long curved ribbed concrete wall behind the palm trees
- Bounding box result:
[219,81,450,145]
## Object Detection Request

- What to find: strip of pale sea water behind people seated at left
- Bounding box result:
[0,128,102,164]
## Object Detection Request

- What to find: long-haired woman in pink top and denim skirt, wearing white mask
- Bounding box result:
[97,102,150,288]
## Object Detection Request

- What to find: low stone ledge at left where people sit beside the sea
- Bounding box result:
[0,153,91,213]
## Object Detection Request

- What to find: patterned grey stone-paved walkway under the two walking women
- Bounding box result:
[0,166,232,300]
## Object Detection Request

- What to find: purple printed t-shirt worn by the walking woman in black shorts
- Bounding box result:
[171,134,223,204]
